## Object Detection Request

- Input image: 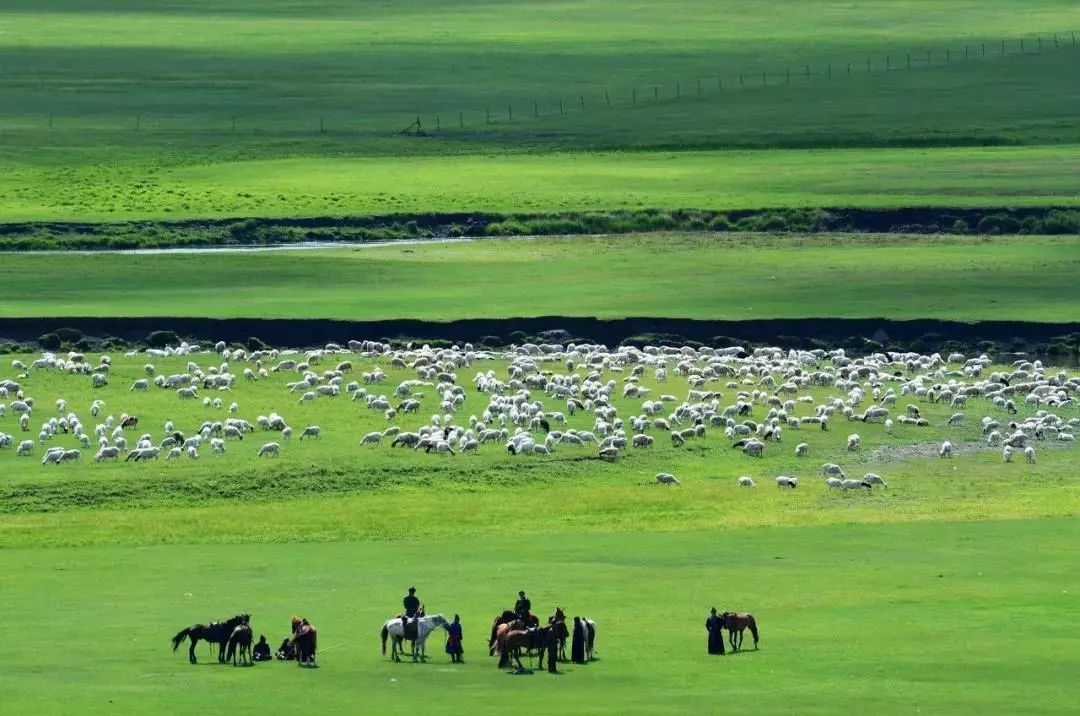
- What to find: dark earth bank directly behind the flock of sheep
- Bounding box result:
[0,316,1080,356]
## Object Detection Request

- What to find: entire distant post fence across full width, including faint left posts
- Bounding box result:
[0,30,1080,143]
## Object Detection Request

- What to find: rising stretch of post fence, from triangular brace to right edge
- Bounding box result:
[401,30,1080,136]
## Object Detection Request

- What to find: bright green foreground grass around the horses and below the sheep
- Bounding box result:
[0,347,1080,714]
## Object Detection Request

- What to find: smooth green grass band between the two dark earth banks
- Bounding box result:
[0,234,1080,322]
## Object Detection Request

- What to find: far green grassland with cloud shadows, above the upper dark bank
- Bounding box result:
[0,0,1080,221]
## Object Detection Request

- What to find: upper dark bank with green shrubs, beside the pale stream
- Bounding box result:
[0,206,1080,251]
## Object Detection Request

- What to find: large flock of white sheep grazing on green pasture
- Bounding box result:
[0,341,1080,491]
